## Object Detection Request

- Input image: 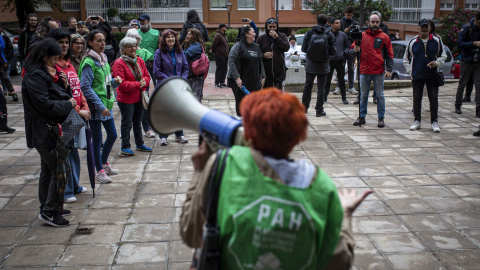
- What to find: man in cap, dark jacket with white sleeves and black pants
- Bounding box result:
[403,19,447,132]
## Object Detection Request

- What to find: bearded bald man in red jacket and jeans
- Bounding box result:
[350,14,393,128]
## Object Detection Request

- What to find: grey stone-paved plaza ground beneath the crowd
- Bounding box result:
[0,74,480,270]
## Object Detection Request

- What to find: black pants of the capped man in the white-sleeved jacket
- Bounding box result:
[412,78,438,123]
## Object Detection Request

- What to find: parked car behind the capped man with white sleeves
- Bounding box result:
[391,40,455,80]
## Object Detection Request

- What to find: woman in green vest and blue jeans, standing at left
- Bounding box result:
[78,30,122,183]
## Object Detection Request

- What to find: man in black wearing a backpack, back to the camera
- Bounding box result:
[302,14,337,117]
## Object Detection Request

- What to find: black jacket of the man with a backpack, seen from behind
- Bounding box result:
[302,24,337,74]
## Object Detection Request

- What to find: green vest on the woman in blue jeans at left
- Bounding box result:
[78,57,115,110]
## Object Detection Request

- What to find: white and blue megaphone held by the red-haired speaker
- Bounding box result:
[148,76,245,147]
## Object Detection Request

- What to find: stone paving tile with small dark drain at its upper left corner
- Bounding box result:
[71,224,124,245]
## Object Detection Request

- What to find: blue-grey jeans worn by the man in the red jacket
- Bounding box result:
[360,73,385,119]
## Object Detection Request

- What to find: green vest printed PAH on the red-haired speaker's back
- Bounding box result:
[217,146,343,270]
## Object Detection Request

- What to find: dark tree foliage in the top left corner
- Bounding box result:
[2,0,63,28]
